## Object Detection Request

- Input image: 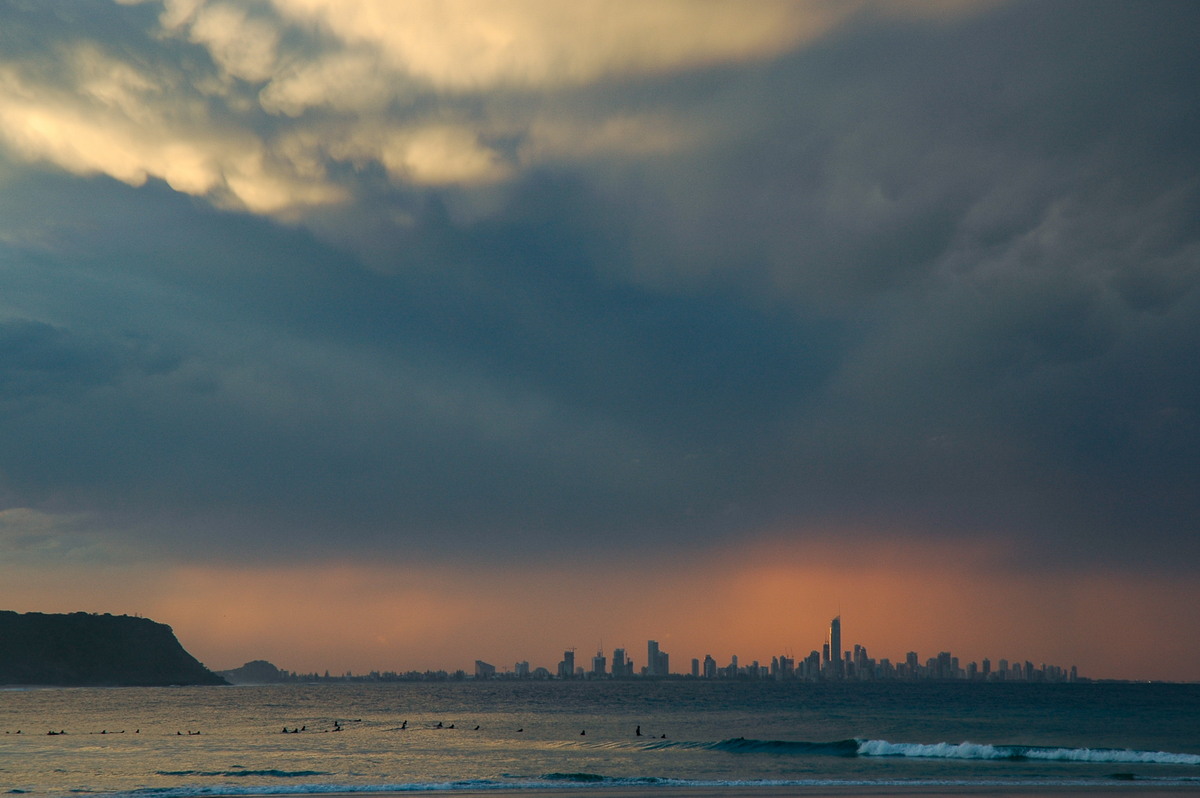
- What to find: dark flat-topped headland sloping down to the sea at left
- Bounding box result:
[0,611,228,686]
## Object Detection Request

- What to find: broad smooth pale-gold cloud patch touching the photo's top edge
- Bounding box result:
[266,0,854,90]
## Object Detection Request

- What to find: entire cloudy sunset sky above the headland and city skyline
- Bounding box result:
[0,0,1200,680]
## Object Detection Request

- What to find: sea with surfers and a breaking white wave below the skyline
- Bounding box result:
[0,680,1200,798]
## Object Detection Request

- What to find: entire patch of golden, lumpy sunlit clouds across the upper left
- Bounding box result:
[0,0,988,217]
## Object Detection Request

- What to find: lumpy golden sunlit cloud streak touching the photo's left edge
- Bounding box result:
[0,42,343,214]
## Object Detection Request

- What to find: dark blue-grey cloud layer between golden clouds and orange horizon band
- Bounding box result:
[0,2,1200,568]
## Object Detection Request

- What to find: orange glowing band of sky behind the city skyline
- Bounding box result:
[6,540,1200,680]
